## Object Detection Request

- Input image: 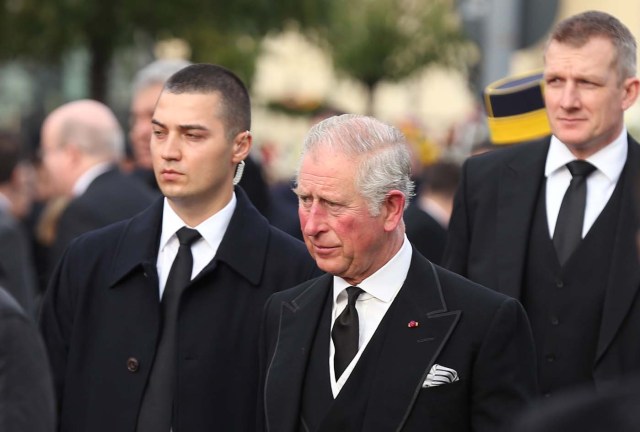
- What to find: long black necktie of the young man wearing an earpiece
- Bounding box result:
[136,227,200,432]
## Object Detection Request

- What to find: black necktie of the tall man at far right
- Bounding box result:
[553,160,596,265]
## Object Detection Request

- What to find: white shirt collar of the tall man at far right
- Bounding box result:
[544,127,628,183]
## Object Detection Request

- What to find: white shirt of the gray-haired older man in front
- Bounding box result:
[329,235,412,398]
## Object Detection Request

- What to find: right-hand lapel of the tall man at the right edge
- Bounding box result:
[595,136,640,365]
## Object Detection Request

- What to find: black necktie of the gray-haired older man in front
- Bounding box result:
[331,287,362,380]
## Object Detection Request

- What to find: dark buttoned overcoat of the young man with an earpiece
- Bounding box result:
[41,188,318,432]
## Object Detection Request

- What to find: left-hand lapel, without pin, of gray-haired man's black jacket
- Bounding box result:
[264,274,333,431]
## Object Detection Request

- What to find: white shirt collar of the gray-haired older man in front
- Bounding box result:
[333,235,412,304]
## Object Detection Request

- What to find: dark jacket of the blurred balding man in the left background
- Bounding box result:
[50,167,160,269]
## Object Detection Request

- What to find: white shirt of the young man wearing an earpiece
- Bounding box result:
[156,193,236,298]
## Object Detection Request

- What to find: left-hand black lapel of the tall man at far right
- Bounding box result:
[496,138,550,298]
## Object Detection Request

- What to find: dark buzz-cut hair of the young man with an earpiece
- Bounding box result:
[164,63,251,141]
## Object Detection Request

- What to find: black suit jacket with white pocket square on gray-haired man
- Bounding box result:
[258,250,536,432]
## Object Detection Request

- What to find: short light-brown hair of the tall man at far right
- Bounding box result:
[545,11,636,82]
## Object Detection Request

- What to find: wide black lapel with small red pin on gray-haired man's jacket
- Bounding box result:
[362,248,462,431]
